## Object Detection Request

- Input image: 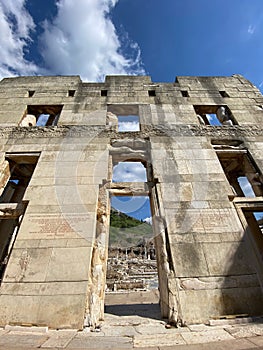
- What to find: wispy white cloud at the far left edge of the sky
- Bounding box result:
[0,0,38,78]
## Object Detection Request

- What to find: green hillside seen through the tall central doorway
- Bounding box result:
[110,208,153,248]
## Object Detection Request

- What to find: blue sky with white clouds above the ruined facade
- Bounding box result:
[0,0,263,219]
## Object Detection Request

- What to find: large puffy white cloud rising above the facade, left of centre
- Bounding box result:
[41,0,144,81]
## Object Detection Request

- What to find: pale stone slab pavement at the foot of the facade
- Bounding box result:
[0,313,263,350]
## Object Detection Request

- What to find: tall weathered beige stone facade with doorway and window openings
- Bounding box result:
[0,75,263,329]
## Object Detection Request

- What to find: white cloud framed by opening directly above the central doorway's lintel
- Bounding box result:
[112,162,147,182]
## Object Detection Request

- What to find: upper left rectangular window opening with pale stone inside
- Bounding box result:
[19,105,63,127]
